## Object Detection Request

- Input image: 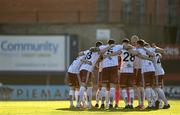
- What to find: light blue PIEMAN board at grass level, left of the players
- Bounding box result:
[0,85,69,100]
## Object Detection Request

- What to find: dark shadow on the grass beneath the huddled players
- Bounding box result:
[56,107,157,112]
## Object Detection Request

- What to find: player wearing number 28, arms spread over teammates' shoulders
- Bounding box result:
[104,39,149,108]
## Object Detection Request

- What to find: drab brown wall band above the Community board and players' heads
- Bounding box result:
[0,23,171,49]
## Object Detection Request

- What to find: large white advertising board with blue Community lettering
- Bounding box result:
[0,36,65,71]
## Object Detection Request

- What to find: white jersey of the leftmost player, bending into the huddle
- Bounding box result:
[68,55,85,74]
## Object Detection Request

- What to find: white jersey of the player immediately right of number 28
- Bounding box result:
[137,48,155,73]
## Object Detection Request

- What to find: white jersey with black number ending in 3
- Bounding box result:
[80,45,106,72]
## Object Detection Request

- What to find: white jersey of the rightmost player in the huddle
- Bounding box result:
[154,53,165,76]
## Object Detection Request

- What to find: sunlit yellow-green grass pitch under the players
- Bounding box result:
[0,100,180,115]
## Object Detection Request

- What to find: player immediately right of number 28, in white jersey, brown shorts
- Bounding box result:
[137,40,155,109]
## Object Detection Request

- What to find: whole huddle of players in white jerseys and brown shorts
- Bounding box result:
[67,35,170,109]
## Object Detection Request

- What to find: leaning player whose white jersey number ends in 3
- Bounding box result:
[77,42,112,108]
